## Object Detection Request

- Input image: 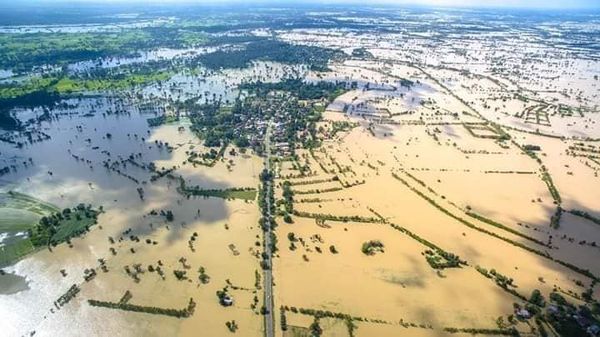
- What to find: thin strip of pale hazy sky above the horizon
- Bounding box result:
[10,0,600,9]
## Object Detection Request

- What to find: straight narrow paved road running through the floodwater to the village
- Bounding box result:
[263,122,275,337]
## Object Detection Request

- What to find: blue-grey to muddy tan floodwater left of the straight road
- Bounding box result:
[0,72,264,336]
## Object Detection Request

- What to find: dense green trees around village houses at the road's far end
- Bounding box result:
[178,79,345,153]
